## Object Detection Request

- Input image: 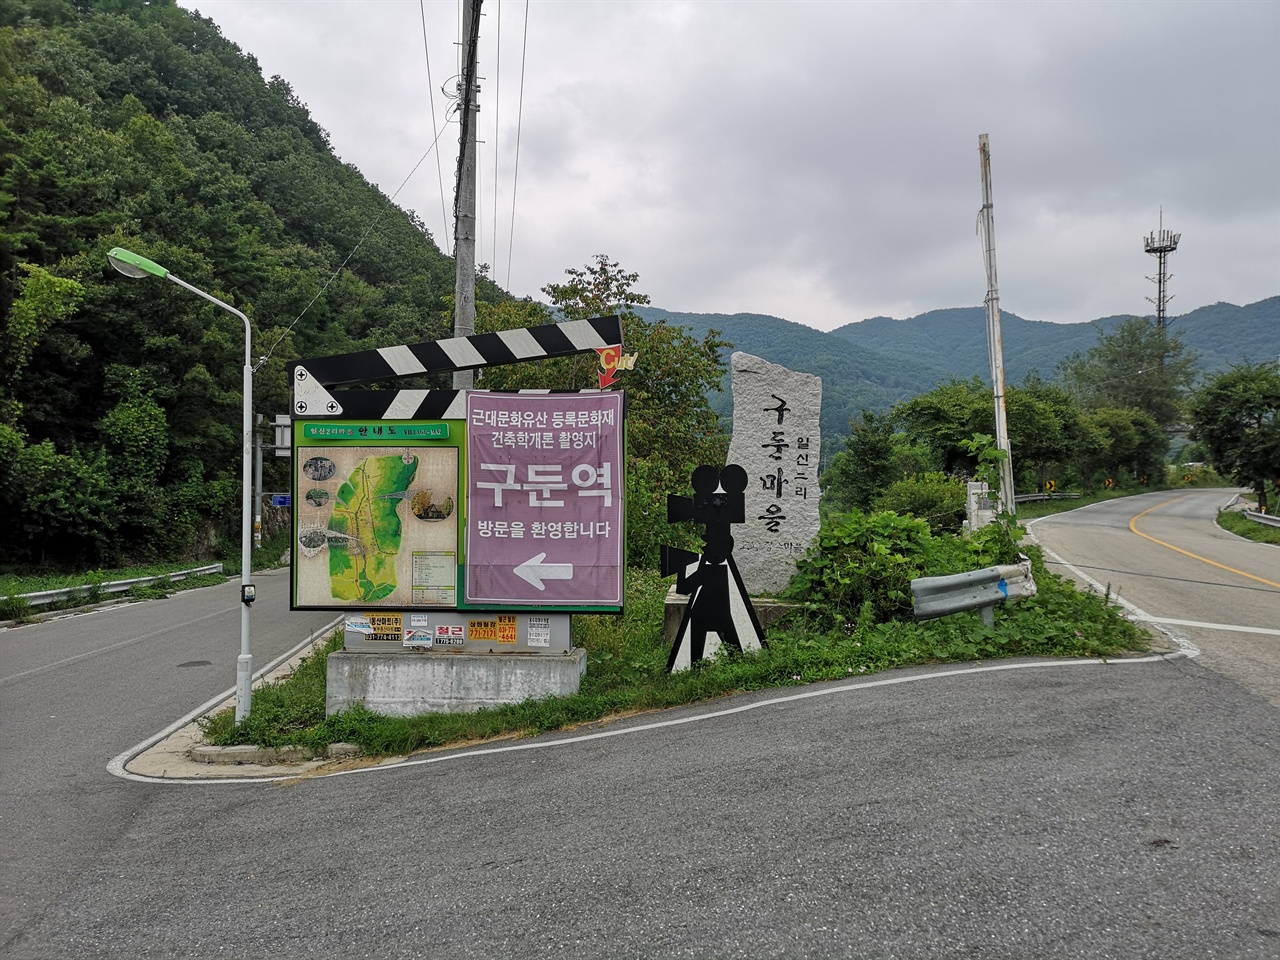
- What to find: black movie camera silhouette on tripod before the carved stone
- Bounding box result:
[662,463,765,673]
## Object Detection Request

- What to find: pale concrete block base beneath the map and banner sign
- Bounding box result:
[325,646,586,717]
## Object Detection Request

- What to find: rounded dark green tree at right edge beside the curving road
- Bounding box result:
[1190,362,1280,509]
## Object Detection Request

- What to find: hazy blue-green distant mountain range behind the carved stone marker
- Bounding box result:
[640,297,1280,434]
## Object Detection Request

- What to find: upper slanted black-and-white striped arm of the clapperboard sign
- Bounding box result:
[291,316,622,389]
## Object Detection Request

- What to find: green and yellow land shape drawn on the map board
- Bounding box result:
[328,453,417,603]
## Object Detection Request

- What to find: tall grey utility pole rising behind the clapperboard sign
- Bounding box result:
[453,0,483,390]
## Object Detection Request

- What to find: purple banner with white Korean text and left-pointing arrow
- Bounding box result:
[466,392,625,607]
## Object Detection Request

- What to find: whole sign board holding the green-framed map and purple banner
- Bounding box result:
[292,390,625,613]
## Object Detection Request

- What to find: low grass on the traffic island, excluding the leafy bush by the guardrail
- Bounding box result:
[205,548,1147,755]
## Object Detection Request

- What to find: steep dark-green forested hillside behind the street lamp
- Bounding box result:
[0,0,504,561]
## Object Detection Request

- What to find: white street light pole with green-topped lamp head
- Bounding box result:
[106,247,256,723]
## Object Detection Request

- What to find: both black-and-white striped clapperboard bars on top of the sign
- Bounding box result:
[289,316,622,420]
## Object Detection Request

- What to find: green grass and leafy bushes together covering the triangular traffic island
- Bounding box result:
[205,511,1147,755]
